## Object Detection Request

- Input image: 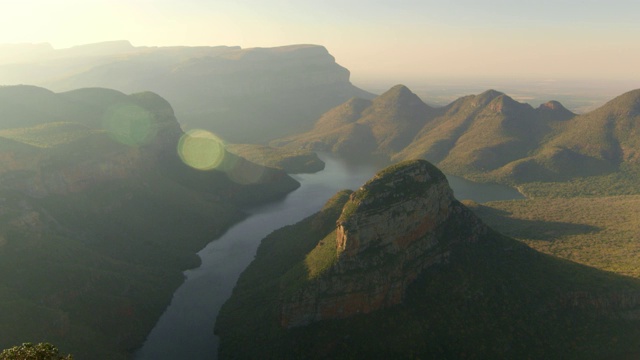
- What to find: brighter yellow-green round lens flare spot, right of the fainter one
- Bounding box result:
[178,130,225,170]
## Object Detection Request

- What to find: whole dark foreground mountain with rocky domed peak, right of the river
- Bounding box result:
[215,160,640,359]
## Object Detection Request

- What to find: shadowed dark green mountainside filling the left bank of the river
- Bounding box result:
[0,86,299,359]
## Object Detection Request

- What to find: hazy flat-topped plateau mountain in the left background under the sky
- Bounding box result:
[0,41,373,143]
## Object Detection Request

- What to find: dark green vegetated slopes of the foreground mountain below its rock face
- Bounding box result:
[216,179,640,359]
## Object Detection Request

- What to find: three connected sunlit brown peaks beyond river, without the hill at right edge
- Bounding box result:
[273,85,573,173]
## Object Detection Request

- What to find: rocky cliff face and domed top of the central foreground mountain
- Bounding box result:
[280,160,487,328]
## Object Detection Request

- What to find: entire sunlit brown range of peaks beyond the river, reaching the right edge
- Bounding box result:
[273,85,640,194]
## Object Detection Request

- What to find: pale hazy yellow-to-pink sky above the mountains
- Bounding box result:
[0,0,640,81]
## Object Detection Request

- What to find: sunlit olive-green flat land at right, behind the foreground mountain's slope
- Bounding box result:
[472,195,640,278]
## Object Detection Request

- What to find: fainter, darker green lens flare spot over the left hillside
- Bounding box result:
[102,104,156,146]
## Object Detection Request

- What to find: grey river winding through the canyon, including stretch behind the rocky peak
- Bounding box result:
[136,154,522,360]
